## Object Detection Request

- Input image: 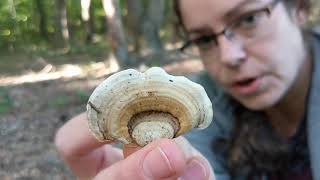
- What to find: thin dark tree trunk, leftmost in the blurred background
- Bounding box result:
[35,0,49,40]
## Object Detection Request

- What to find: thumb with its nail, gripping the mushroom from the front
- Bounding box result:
[95,139,187,180]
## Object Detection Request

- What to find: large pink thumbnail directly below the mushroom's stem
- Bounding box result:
[143,147,173,179]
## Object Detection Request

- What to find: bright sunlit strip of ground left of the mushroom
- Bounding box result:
[0,58,119,86]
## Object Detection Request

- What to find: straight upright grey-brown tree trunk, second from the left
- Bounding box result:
[55,0,69,48]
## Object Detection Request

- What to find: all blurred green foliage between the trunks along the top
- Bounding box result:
[0,0,180,54]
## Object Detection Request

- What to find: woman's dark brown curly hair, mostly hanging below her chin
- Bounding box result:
[174,0,313,179]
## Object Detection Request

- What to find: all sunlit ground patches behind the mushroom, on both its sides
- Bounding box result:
[0,50,203,86]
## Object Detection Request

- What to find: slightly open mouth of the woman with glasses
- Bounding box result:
[231,77,261,96]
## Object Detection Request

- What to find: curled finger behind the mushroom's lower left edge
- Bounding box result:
[55,113,123,179]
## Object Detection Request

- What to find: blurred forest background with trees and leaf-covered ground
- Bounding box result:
[0,0,319,180]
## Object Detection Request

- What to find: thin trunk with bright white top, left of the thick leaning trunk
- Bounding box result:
[81,0,94,43]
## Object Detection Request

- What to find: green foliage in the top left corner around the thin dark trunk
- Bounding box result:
[0,0,53,48]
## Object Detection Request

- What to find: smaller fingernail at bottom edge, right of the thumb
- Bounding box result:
[178,159,207,180]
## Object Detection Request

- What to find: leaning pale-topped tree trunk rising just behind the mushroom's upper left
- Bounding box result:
[102,0,135,67]
